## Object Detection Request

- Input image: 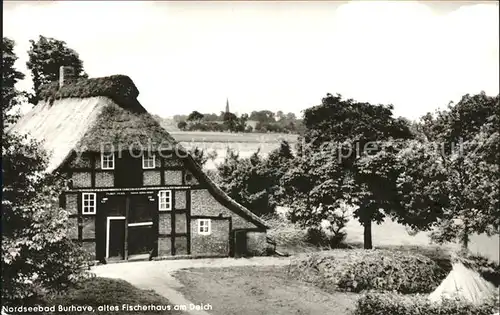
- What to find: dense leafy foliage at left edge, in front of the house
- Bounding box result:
[2,134,85,304]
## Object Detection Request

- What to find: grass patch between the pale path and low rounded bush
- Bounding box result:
[174,267,358,315]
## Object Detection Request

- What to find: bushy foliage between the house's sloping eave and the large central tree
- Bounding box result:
[217,142,293,215]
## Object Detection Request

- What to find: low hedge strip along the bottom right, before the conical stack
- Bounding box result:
[354,293,498,315]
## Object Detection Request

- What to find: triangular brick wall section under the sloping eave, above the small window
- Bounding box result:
[191,189,256,229]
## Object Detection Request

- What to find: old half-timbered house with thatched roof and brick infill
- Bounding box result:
[13,67,267,261]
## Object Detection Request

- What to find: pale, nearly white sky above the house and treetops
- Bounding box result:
[3,1,499,119]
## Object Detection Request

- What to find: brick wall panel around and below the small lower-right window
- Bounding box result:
[191,219,229,256]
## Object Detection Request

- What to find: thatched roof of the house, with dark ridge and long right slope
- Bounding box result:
[9,76,267,228]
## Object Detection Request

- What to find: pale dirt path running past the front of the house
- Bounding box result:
[91,257,290,315]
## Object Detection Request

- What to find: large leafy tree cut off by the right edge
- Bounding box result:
[398,93,500,248]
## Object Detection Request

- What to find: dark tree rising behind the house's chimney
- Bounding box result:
[26,35,87,93]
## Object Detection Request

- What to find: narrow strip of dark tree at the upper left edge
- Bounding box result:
[2,37,24,123]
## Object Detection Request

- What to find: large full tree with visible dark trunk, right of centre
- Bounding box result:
[283,94,412,248]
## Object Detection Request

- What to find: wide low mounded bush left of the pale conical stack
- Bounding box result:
[290,250,446,293]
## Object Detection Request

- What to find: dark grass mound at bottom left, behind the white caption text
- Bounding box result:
[44,277,185,315]
